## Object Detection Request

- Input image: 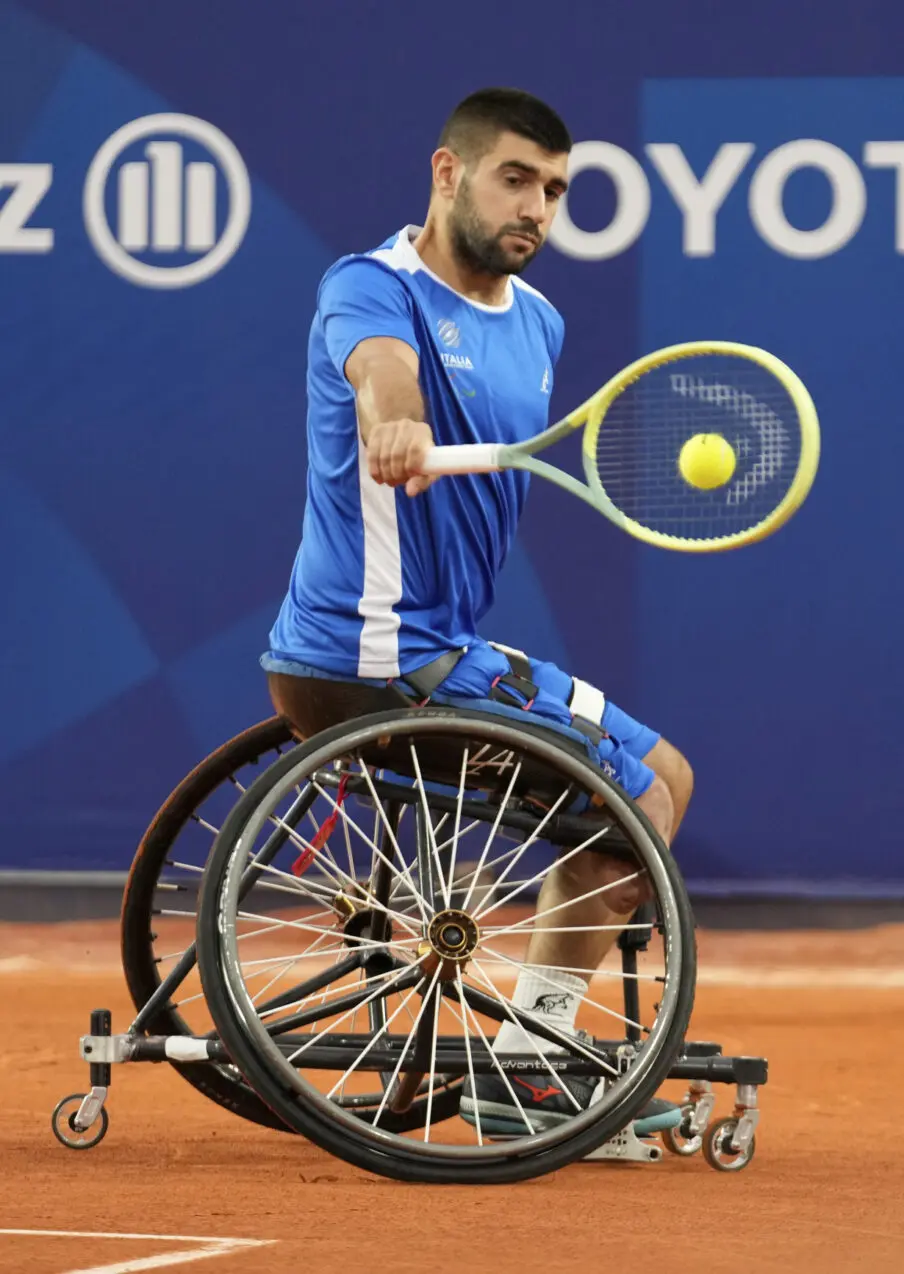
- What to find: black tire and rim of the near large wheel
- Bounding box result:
[197,707,695,1185]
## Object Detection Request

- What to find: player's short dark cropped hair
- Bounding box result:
[438,88,572,163]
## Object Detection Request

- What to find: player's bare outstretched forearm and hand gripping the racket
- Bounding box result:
[345,336,433,496]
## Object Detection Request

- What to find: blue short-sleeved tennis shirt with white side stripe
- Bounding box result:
[270,225,564,679]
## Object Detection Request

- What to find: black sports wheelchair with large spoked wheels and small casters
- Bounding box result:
[52,698,766,1184]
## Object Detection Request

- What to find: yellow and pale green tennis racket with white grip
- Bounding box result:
[423,340,820,553]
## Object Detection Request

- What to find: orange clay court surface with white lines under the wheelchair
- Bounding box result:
[0,922,904,1274]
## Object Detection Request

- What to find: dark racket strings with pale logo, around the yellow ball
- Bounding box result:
[595,354,801,539]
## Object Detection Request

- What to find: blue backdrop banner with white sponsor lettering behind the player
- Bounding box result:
[0,0,904,893]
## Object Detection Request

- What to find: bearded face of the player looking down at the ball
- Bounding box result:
[448,132,568,275]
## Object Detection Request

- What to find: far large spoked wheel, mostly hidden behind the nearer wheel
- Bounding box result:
[121,717,295,1130]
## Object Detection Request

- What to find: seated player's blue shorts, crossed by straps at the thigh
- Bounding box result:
[261,640,660,800]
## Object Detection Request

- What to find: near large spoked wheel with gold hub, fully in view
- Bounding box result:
[197,707,695,1184]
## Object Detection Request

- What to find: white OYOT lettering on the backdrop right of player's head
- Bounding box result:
[550,138,904,261]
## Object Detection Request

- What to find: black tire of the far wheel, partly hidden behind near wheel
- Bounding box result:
[120,717,295,1133]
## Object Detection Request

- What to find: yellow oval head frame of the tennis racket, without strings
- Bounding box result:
[578,340,820,553]
